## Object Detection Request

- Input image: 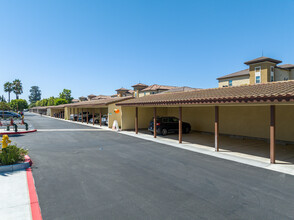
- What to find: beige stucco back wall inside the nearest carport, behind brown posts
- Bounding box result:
[122,105,294,141]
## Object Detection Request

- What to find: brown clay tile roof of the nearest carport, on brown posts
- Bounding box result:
[117,80,294,106]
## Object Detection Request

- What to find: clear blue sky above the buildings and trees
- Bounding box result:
[0,0,294,99]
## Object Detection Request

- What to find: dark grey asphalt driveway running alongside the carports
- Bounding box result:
[11,113,294,220]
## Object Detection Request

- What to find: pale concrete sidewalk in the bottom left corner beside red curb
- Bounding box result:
[0,170,32,220]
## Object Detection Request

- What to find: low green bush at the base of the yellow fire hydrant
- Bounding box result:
[0,145,28,165]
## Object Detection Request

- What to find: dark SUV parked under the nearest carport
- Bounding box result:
[148,117,191,135]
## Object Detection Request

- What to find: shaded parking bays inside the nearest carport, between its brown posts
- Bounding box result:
[122,105,294,164]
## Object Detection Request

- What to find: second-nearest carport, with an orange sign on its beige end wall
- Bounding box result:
[53,97,133,127]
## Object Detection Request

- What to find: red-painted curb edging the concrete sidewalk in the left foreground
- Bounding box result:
[26,158,42,220]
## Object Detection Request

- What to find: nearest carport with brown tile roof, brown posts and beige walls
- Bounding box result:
[117,81,294,163]
